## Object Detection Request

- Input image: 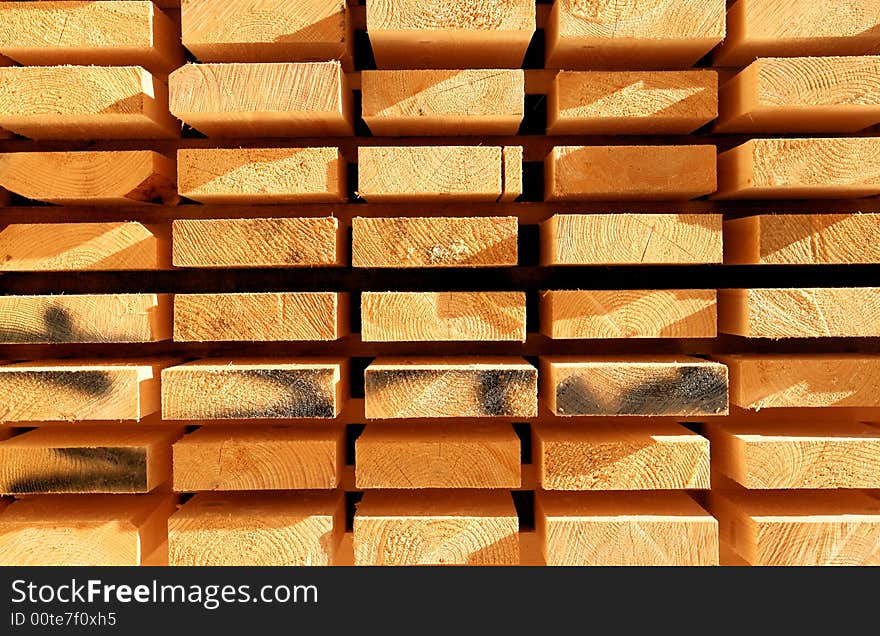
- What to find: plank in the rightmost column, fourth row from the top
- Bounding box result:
[724,214,880,265]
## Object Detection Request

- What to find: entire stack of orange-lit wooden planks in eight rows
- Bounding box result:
[0,0,880,566]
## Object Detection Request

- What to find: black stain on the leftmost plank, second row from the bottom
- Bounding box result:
[6,446,147,495]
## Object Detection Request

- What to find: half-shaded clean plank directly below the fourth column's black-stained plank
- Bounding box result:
[532,421,709,490]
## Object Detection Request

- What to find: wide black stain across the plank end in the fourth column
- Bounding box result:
[556,366,728,415]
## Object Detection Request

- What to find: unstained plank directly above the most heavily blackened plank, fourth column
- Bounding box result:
[540,289,718,339]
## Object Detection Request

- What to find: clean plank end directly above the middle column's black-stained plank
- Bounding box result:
[361,292,526,342]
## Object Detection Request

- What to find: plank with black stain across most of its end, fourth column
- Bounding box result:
[540,356,728,416]
